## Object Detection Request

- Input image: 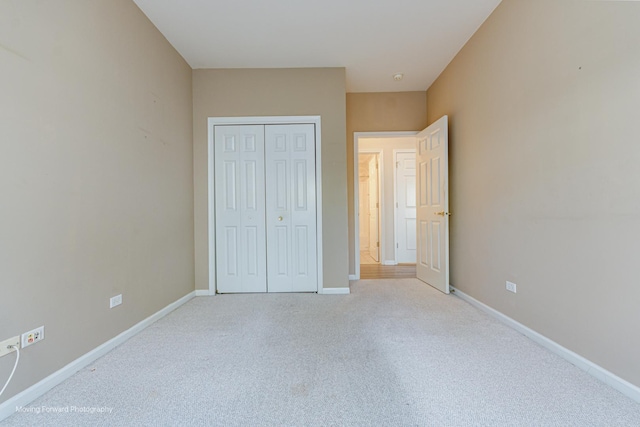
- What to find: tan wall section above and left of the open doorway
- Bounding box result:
[347,91,427,274]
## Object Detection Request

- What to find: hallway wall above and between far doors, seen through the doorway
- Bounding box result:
[358,137,416,264]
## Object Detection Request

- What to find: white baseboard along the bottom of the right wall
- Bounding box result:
[452,287,640,403]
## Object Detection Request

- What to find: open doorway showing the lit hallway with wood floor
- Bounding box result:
[353,132,417,280]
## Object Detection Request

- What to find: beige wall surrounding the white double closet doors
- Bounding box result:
[193,68,349,289]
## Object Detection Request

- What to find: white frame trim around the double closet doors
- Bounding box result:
[207,116,324,295]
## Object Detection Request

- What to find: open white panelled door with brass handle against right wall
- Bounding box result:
[416,116,451,294]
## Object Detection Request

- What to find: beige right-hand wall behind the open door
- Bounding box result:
[427,0,640,386]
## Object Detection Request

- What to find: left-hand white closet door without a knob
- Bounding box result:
[214,125,267,293]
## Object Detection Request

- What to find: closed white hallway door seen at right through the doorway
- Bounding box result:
[396,151,416,264]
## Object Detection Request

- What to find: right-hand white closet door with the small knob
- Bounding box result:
[265,124,318,292]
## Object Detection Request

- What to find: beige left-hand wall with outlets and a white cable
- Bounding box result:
[0,0,194,401]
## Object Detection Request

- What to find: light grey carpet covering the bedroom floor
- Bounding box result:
[2,279,640,426]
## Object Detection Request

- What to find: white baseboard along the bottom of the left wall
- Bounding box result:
[0,291,196,421]
